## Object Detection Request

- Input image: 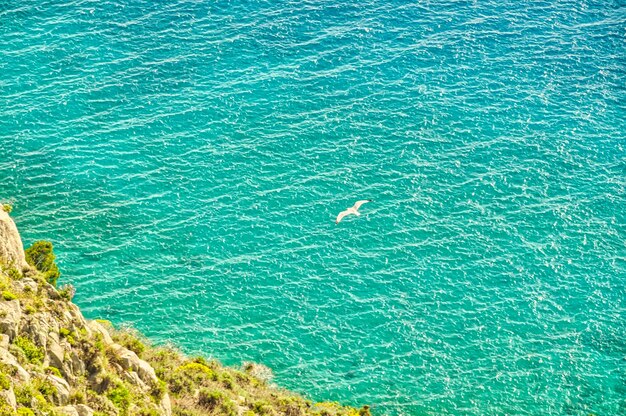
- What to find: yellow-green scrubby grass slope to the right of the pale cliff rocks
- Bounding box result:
[101,321,370,416]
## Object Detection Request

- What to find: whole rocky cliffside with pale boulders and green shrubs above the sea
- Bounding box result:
[0,209,369,416]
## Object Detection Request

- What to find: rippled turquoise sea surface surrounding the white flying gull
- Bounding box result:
[0,0,626,415]
